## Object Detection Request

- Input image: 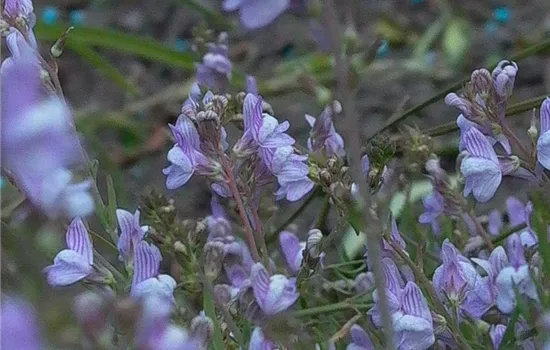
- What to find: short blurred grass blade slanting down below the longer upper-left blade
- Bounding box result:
[67,42,140,97]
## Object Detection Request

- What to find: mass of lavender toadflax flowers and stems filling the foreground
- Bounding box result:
[0,0,550,350]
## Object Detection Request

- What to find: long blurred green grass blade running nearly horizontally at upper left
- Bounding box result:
[34,22,195,71]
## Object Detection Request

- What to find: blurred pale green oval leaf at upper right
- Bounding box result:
[443,18,472,68]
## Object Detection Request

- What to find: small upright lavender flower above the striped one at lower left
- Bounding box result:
[116,209,149,264]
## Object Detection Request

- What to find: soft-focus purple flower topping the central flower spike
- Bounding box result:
[197,33,231,93]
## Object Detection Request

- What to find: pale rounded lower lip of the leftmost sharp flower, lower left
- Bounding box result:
[44,249,93,287]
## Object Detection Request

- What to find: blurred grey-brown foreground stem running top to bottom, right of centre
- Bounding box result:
[324,0,396,350]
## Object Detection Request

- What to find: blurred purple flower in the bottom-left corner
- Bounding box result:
[0,295,45,350]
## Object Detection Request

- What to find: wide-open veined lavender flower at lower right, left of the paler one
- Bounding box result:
[433,239,493,319]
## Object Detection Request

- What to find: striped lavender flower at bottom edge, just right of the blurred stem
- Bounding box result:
[368,258,435,350]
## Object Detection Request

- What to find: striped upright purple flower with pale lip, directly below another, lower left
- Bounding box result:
[131,241,176,301]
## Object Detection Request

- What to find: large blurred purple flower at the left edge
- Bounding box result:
[0,52,94,218]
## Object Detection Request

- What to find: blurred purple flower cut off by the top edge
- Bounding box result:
[223,0,291,29]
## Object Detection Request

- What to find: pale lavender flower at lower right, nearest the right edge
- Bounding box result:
[495,234,539,314]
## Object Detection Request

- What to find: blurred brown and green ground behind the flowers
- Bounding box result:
[0,0,550,344]
